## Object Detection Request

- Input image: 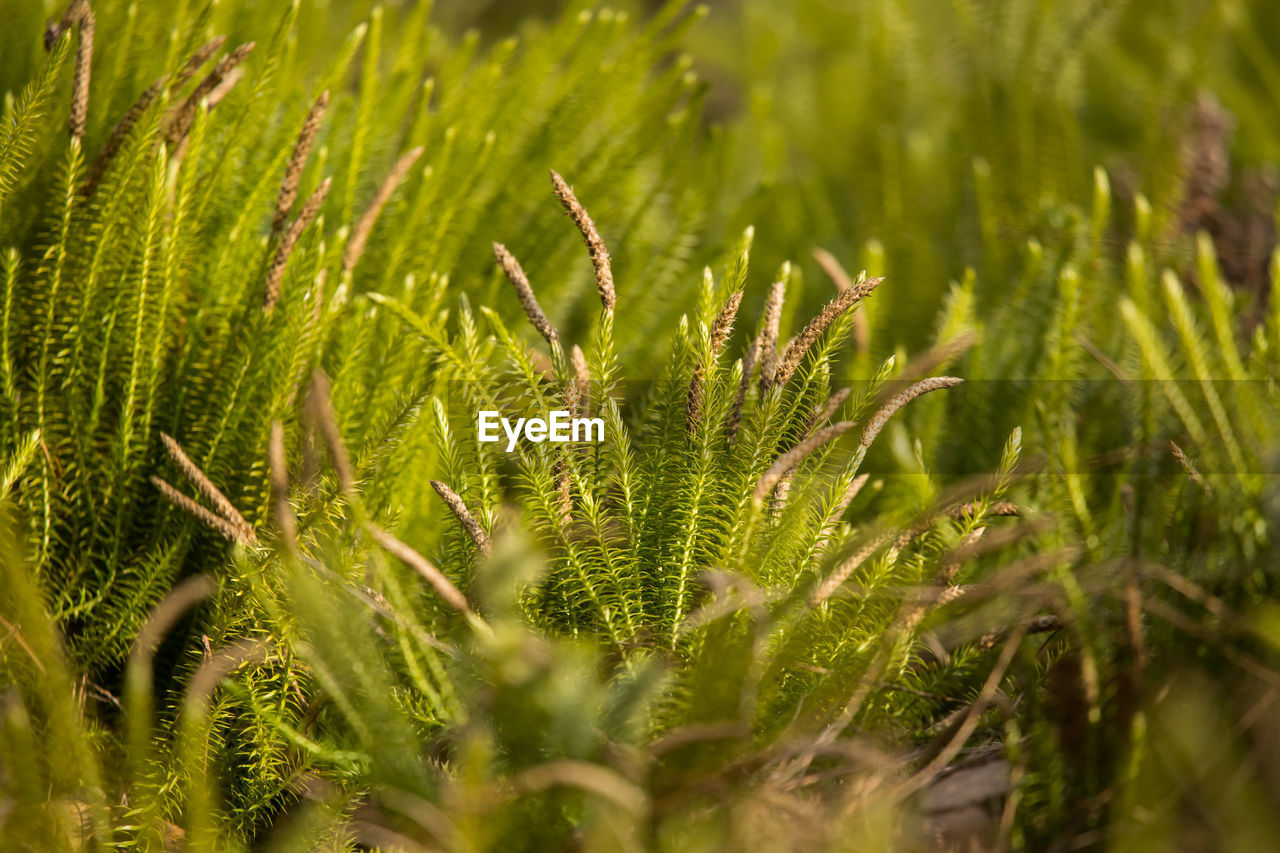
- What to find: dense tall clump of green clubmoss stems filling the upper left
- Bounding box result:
[0,5,716,669]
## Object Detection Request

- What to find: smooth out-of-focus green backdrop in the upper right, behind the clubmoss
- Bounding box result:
[439,0,1280,352]
